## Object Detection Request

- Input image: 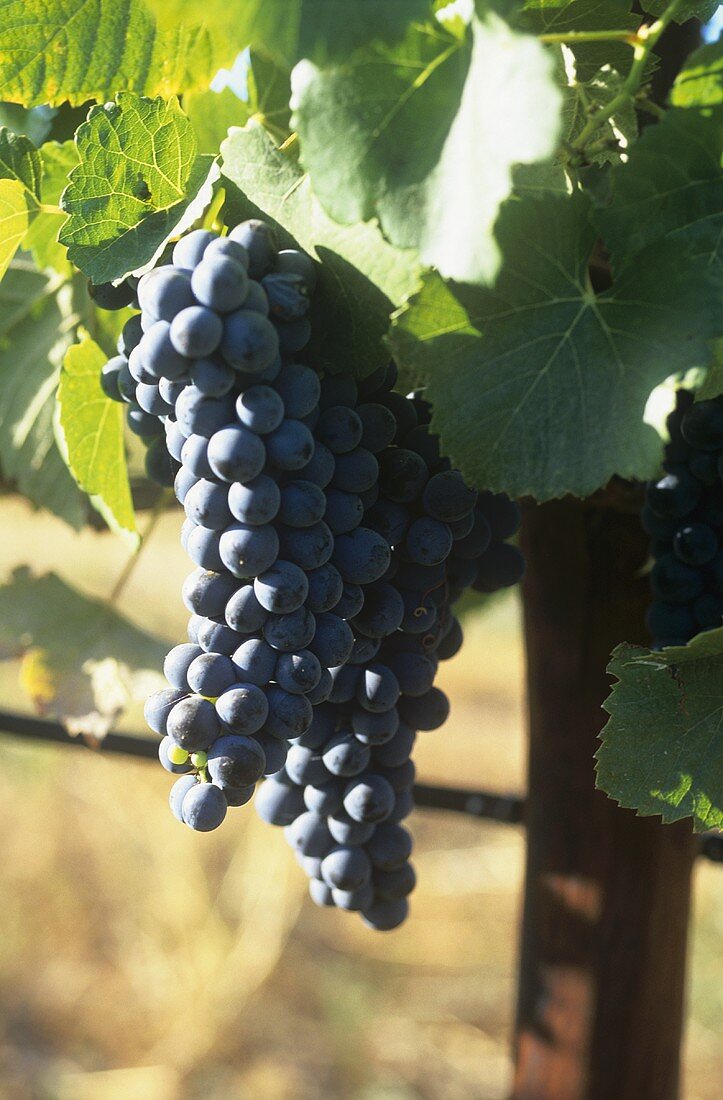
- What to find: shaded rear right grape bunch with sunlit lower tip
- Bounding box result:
[250,382,524,930]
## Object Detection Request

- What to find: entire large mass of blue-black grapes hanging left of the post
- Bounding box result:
[94,221,524,928]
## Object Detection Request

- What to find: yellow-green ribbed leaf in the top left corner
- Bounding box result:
[0,0,225,107]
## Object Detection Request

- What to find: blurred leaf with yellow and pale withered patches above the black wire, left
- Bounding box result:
[0,567,167,738]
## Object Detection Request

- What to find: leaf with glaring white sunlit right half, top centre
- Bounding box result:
[292,13,561,283]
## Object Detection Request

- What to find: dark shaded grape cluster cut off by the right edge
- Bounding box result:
[643,389,723,649]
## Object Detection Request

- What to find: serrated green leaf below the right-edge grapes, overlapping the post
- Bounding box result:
[596,629,723,832]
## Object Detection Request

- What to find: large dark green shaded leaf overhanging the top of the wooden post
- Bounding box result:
[391,195,721,501]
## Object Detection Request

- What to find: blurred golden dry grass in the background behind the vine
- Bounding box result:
[0,503,723,1100]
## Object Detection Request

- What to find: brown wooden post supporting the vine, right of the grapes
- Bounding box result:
[513,486,694,1100]
